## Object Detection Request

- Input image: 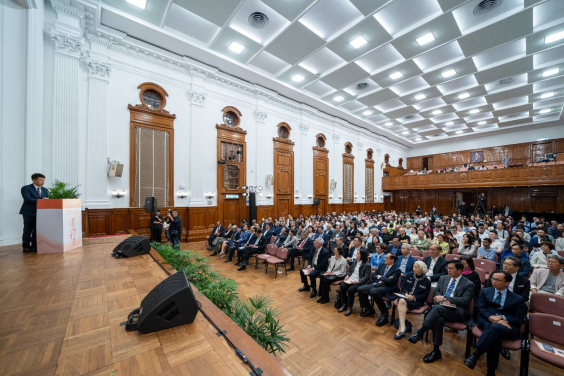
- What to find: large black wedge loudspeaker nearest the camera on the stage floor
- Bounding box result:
[137,271,198,333]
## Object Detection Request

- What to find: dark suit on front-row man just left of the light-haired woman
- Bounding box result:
[358,264,401,317]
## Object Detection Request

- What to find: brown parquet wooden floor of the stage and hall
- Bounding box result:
[0,238,558,376]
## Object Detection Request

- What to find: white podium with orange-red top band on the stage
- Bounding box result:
[36,199,82,253]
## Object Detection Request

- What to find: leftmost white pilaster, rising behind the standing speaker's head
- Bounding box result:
[25,1,44,178]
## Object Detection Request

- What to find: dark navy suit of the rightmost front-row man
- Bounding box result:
[476,287,527,370]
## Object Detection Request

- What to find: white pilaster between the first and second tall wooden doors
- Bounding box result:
[189,89,207,206]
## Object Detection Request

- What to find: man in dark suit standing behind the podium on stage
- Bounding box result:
[20,174,49,252]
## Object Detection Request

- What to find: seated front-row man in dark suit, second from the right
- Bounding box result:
[407,260,474,363]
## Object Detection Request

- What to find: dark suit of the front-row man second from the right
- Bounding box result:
[423,275,474,346]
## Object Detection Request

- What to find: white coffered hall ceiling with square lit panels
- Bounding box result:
[101,0,564,146]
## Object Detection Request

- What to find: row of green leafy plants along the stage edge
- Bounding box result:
[151,243,289,355]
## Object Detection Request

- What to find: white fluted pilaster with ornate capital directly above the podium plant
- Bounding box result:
[51,30,84,186]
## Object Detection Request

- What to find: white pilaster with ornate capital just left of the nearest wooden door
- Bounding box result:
[83,59,112,208]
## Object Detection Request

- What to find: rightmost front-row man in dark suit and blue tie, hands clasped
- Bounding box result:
[464,270,527,376]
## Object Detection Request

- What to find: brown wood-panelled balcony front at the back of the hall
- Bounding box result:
[382,164,564,191]
